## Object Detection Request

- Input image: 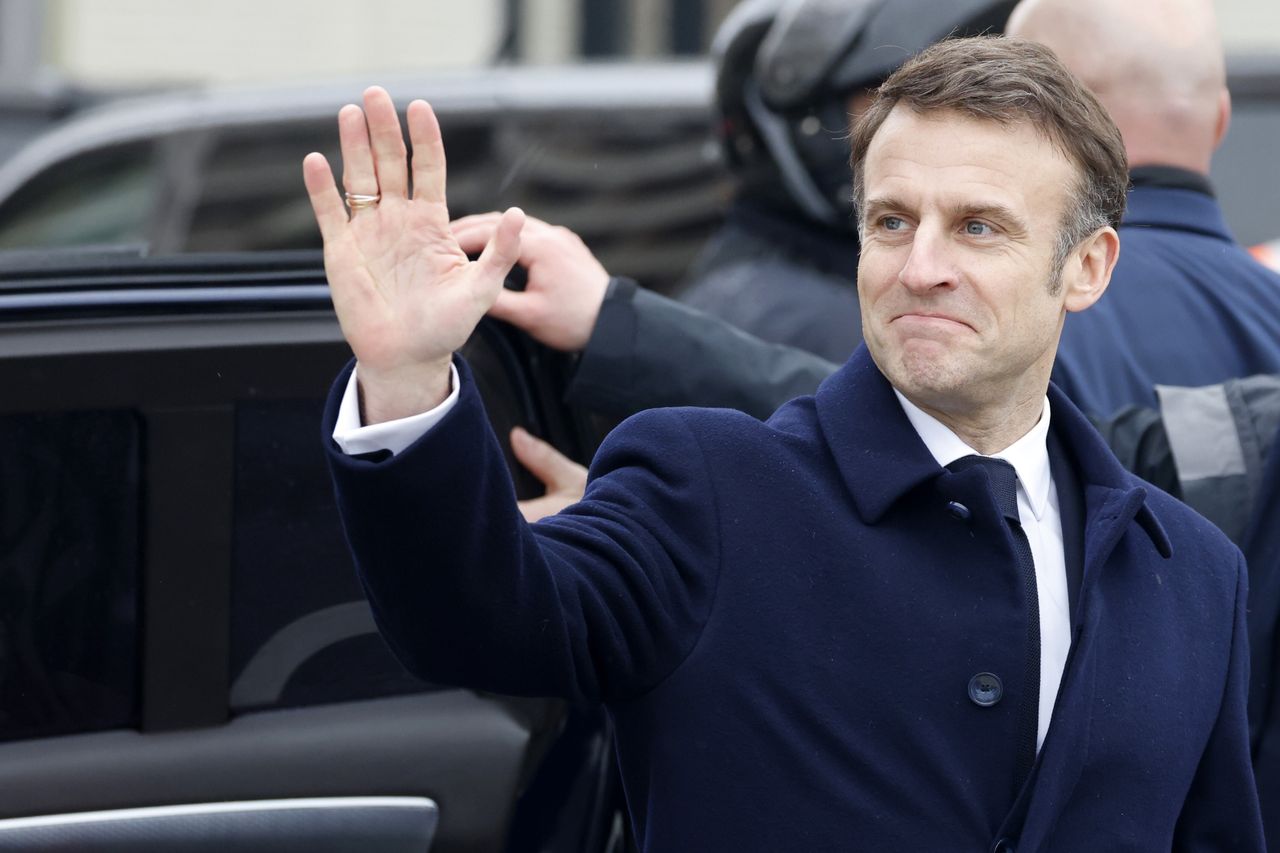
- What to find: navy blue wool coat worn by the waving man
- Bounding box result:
[325,348,1262,853]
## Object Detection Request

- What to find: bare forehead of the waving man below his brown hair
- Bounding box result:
[863,104,1078,223]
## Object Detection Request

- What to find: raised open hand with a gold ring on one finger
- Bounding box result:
[302,86,525,424]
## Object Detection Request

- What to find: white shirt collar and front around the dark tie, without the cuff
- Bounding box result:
[893,389,1071,749]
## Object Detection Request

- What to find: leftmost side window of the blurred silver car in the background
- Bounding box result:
[0,142,161,248]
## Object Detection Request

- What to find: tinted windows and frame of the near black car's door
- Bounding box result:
[0,279,577,739]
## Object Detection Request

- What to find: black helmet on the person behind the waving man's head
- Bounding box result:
[712,0,1016,228]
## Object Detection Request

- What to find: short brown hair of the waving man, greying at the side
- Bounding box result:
[852,36,1129,269]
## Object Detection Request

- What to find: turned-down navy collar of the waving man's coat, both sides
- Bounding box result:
[815,345,1172,557]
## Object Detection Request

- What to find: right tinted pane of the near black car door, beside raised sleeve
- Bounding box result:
[230,323,576,712]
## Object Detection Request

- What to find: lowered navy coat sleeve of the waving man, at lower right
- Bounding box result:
[1172,548,1266,853]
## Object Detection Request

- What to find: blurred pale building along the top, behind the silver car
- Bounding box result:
[0,0,1280,90]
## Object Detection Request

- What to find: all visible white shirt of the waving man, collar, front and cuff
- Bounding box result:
[333,365,1071,749]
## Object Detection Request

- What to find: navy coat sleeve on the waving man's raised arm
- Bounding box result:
[326,360,721,701]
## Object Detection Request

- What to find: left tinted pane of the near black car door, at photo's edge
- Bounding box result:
[0,411,142,739]
